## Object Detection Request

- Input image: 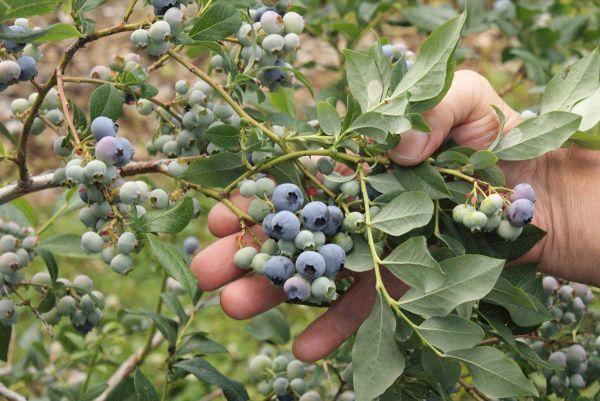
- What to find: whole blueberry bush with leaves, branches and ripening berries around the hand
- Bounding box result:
[0,0,600,401]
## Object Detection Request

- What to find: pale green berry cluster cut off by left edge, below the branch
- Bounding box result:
[0,218,39,286]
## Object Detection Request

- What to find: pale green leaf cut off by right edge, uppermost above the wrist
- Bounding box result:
[540,48,600,114]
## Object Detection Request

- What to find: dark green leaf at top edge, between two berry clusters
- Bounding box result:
[189,2,242,41]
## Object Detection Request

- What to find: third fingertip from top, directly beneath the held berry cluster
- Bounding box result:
[221,275,285,320]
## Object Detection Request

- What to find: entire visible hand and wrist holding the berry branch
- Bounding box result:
[191,70,600,362]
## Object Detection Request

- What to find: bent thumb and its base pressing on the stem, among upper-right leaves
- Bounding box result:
[390,70,520,166]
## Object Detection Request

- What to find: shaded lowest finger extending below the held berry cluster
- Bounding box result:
[293,270,408,362]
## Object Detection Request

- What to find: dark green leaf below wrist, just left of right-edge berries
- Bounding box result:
[484,277,552,327]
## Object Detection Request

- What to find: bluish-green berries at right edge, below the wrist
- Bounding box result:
[529,276,600,394]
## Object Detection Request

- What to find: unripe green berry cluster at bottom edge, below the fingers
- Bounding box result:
[248,347,355,401]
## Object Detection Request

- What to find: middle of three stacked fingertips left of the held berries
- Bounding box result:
[190,226,266,291]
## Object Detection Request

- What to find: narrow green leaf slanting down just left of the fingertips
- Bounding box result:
[146,234,198,299]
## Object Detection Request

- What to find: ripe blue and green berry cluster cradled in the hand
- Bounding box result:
[234,177,364,303]
